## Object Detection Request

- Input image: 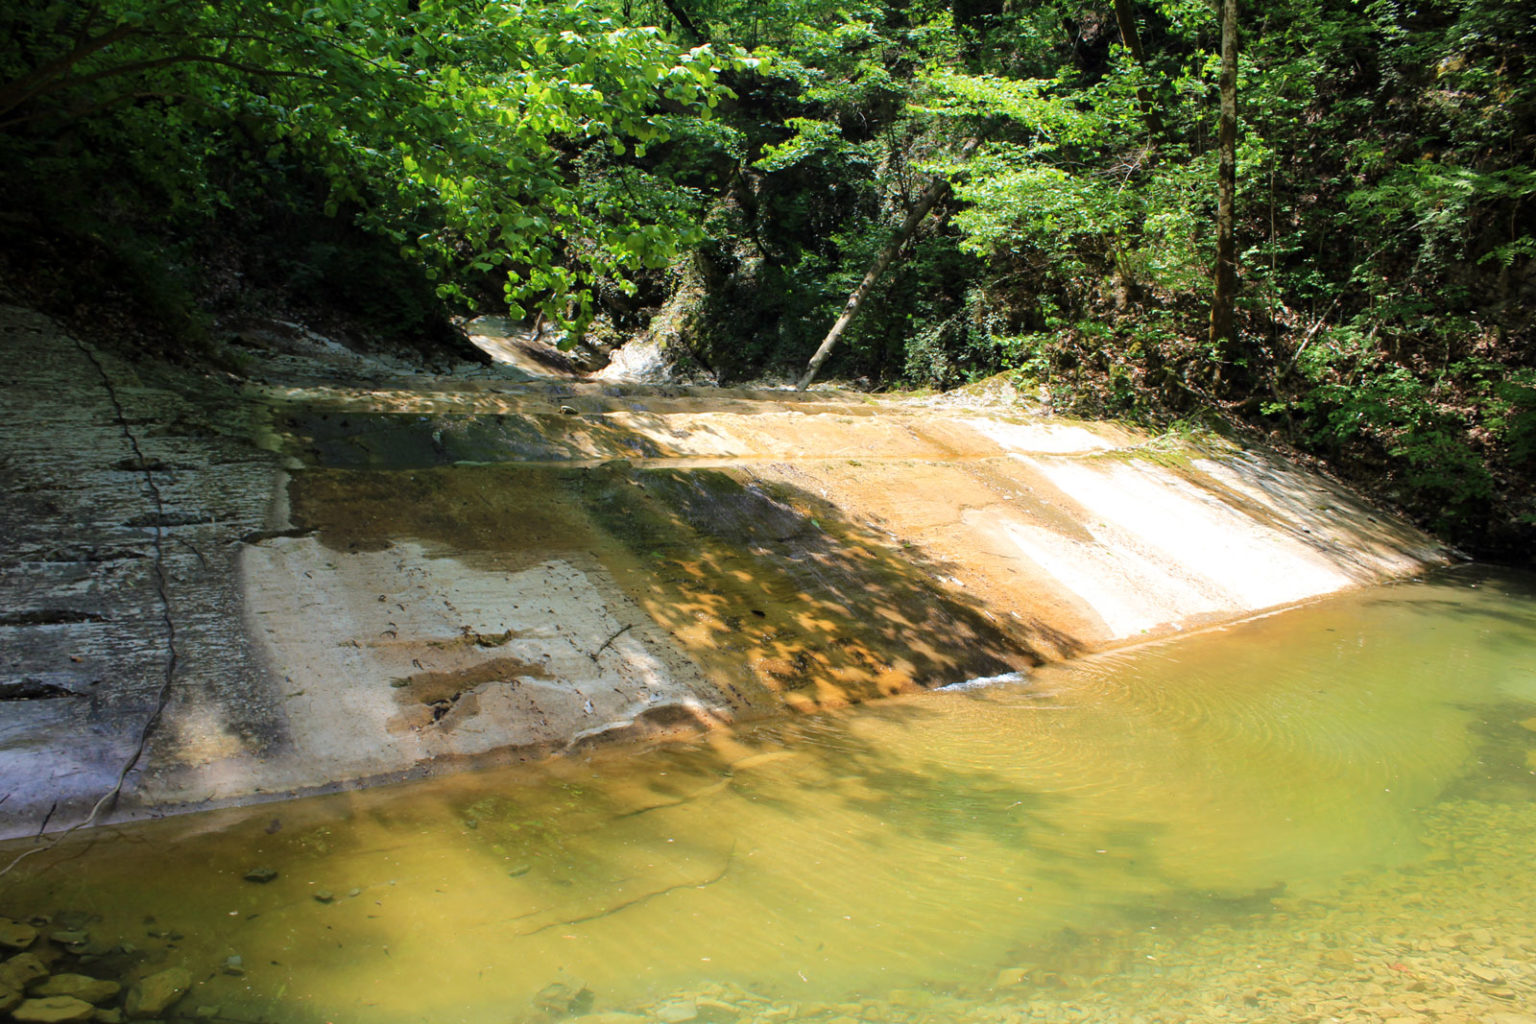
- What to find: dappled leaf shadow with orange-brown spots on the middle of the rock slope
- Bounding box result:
[573,467,1041,711]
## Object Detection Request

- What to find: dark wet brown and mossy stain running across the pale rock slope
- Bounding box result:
[290,415,1056,712]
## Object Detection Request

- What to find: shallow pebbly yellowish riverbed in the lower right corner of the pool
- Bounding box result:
[559,801,1536,1024]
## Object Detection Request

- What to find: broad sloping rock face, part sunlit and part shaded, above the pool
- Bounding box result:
[0,310,1445,835]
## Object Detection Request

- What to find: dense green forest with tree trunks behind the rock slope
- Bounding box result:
[0,0,1536,562]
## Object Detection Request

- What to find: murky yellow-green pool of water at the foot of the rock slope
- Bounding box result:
[0,570,1536,1024]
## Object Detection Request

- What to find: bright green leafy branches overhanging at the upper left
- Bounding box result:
[0,0,746,333]
